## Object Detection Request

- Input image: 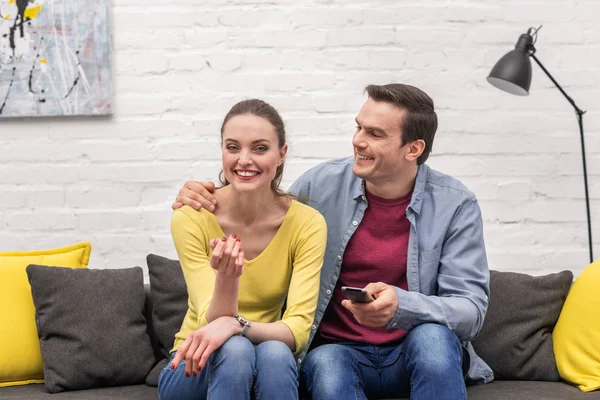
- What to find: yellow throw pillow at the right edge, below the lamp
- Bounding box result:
[552,260,600,392]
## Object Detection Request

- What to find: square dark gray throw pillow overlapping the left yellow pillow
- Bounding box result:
[27,265,155,393]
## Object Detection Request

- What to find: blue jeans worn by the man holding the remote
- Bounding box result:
[300,324,468,400]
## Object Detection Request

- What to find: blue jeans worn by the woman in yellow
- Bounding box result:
[158,336,298,400]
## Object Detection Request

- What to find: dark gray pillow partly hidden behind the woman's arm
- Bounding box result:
[146,254,188,358]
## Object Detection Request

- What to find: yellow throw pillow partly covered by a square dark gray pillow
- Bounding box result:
[0,242,92,387]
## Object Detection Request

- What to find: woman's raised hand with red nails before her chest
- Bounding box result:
[210,233,244,278]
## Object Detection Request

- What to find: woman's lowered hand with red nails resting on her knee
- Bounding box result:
[171,317,241,377]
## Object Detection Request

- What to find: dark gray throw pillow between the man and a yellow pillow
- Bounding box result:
[473,271,573,381]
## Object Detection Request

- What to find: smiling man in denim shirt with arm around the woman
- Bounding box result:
[173,84,493,400]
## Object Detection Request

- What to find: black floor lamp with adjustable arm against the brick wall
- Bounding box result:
[487,26,594,263]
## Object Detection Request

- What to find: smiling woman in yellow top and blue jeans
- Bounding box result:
[159,99,327,400]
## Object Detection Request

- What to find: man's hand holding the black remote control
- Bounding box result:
[342,282,398,328]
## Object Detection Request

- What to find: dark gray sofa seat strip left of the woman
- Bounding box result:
[0,384,158,400]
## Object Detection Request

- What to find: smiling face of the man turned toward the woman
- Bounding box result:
[352,98,410,184]
